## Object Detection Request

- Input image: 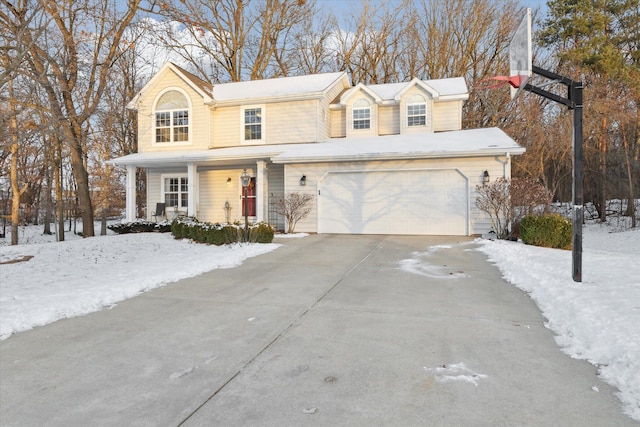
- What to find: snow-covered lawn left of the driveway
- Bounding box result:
[0,231,280,340]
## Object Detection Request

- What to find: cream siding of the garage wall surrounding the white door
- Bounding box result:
[285,156,506,235]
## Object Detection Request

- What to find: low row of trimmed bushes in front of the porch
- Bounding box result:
[171,217,274,246]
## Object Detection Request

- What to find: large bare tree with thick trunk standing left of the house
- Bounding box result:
[2,0,140,237]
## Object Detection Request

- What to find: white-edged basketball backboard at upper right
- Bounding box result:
[509,8,533,99]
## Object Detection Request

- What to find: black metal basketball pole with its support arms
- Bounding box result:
[524,65,584,282]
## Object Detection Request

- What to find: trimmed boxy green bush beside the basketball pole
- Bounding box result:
[520,214,572,249]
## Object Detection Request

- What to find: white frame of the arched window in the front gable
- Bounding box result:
[151,87,193,146]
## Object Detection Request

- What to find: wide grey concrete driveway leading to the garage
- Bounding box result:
[0,235,638,426]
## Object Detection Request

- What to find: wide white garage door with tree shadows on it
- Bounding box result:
[318,169,469,235]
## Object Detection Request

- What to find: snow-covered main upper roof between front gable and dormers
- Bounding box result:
[213,72,345,101]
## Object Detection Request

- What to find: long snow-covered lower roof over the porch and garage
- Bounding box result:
[109,128,525,167]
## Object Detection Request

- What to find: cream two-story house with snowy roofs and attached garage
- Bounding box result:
[112,63,524,235]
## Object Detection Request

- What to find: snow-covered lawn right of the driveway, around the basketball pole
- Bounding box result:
[479,224,640,421]
